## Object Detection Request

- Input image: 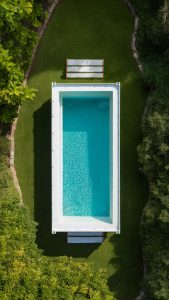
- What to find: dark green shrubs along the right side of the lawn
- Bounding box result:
[132,0,169,300]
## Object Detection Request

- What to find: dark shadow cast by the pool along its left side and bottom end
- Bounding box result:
[34,100,98,257]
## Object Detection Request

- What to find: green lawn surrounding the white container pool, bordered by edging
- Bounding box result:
[15,0,147,300]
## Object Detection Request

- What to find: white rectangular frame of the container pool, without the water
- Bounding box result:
[51,82,120,234]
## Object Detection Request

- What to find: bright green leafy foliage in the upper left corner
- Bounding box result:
[0,0,46,123]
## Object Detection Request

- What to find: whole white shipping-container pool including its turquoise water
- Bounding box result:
[52,83,120,233]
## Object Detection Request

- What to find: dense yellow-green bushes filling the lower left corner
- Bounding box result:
[0,137,113,300]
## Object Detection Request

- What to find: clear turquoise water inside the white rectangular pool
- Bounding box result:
[62,92,110,216]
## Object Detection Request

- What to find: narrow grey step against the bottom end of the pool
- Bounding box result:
[67,232,104,244]
